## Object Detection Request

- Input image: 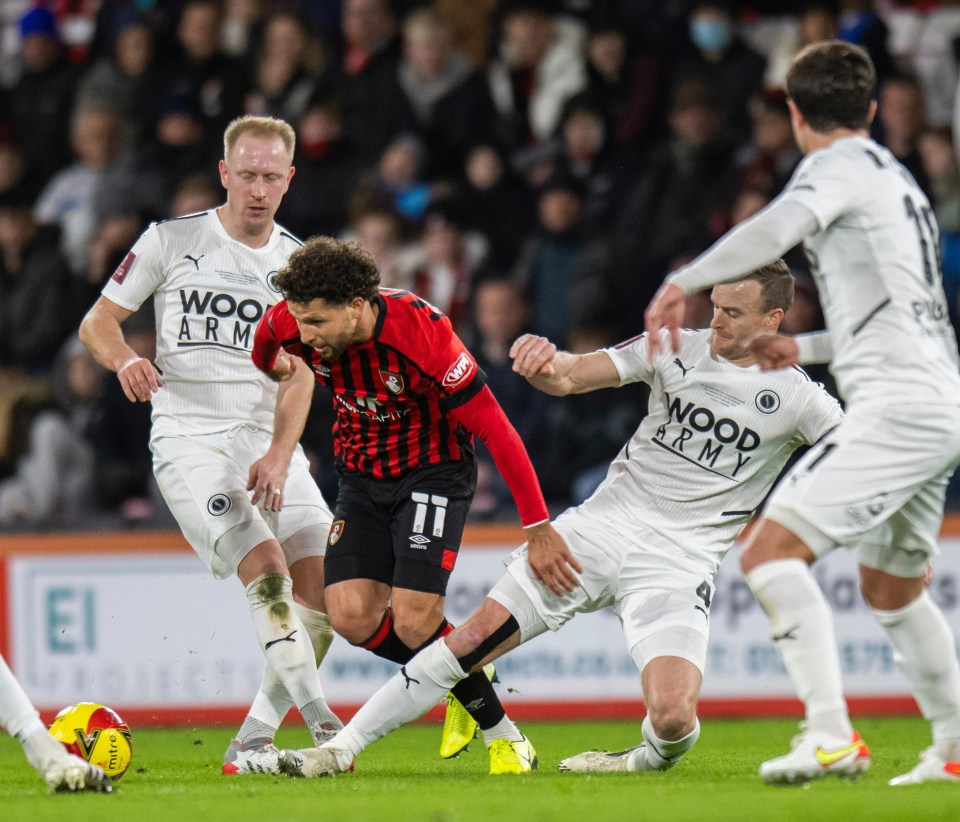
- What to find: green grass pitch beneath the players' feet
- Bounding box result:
[0,719,960,822]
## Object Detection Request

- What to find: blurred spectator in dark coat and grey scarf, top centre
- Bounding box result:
[392,8,493,176]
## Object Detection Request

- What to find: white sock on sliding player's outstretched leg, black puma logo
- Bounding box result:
[330,638,466,756]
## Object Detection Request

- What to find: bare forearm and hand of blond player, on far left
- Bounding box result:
[80,297,163,402]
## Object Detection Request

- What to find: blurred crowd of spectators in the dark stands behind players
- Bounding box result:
[0,0,960,528]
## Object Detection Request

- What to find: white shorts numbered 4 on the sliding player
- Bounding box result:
[488,511,713,673]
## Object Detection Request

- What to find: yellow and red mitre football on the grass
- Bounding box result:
[50,702,133,779]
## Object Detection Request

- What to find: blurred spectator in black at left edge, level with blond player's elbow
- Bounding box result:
[0,183,74,373]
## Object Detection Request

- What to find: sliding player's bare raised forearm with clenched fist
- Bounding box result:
[510,334,620,397]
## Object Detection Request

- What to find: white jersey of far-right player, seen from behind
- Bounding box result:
[781,137,960,405]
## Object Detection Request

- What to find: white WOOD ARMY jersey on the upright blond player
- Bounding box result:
[103,209,301,440]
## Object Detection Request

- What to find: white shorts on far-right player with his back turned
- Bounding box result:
[763,406,960,577]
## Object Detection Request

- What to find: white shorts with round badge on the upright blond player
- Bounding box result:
[151,426,333,579]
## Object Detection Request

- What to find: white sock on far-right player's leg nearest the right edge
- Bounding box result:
[873,591,960,762]
